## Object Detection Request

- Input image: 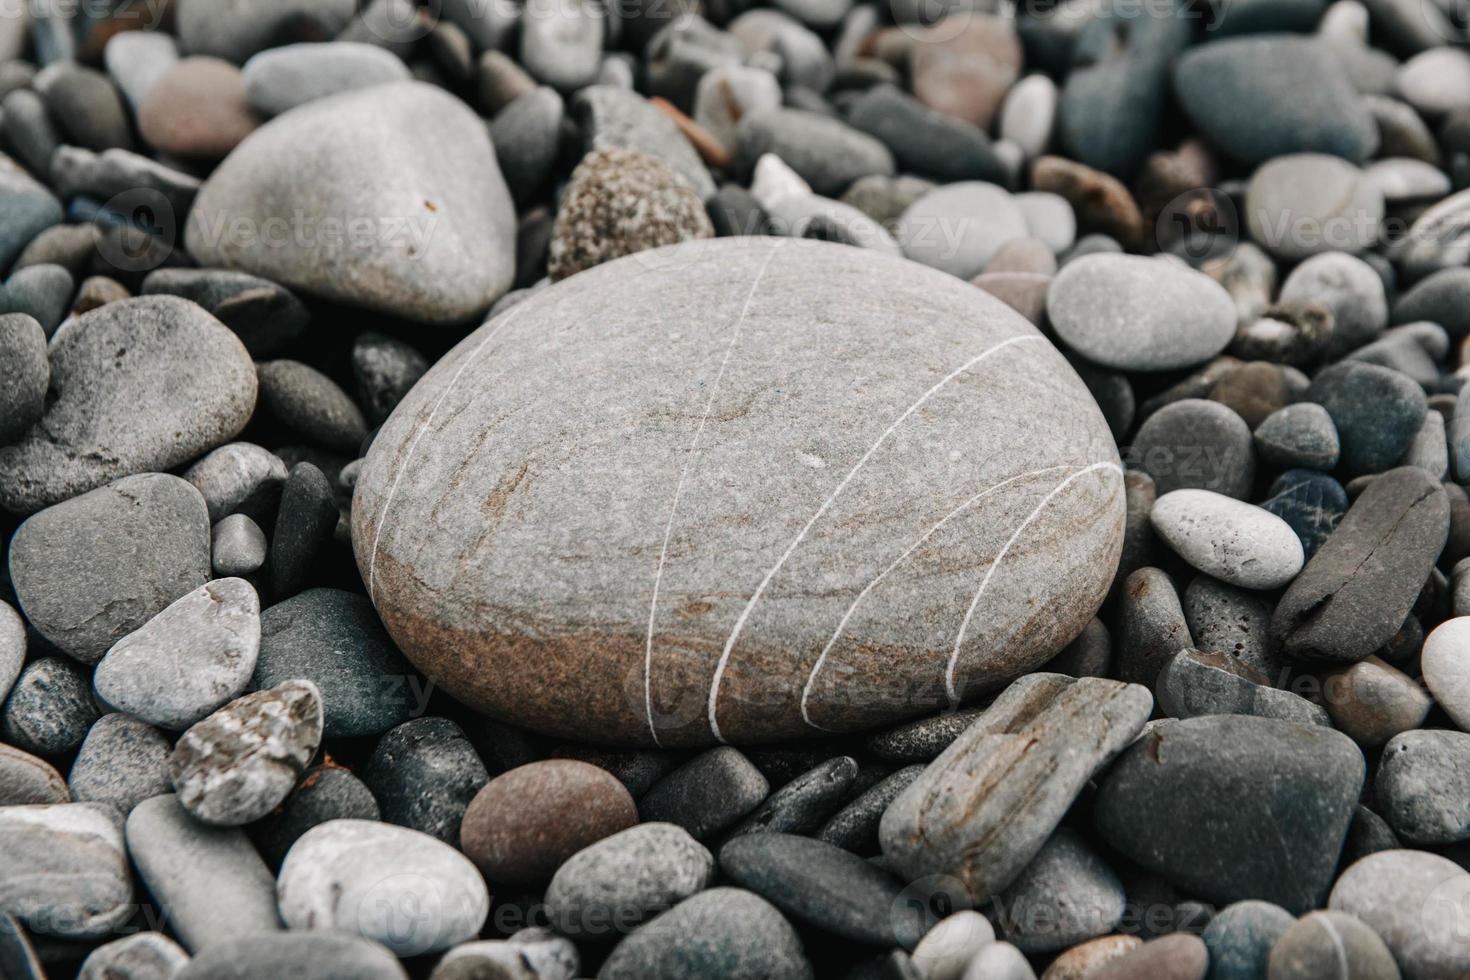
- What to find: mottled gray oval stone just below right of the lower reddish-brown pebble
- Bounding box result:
[545,821,714,937]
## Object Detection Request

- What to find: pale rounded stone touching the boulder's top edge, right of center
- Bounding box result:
[898,181,1030,279]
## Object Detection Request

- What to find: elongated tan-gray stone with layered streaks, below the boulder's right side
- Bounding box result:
[879,673,1154,902]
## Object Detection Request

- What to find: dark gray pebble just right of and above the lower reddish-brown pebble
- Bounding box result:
[638,745,770,840]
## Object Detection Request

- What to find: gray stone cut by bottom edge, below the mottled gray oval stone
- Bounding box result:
[597,887,811,980]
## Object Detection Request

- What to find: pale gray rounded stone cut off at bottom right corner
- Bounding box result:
[1327,849,1470,980]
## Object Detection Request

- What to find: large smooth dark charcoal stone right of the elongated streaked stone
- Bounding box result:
[1094,714,1366,914]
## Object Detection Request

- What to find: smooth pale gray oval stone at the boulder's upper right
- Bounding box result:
[1047,254,1235,370]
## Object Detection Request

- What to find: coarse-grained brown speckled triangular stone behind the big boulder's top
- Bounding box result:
[547,150,714,279]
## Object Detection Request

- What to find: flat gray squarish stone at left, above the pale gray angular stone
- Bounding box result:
[10,473,209,664]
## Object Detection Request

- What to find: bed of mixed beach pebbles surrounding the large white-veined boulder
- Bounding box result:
[0,0,1470,980]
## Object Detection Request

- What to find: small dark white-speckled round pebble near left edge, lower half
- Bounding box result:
[0,657,98,755]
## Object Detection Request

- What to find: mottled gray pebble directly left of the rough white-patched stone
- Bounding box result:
[68,713,173,815]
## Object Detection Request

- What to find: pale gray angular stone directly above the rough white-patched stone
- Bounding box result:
[93,579,260,732]
